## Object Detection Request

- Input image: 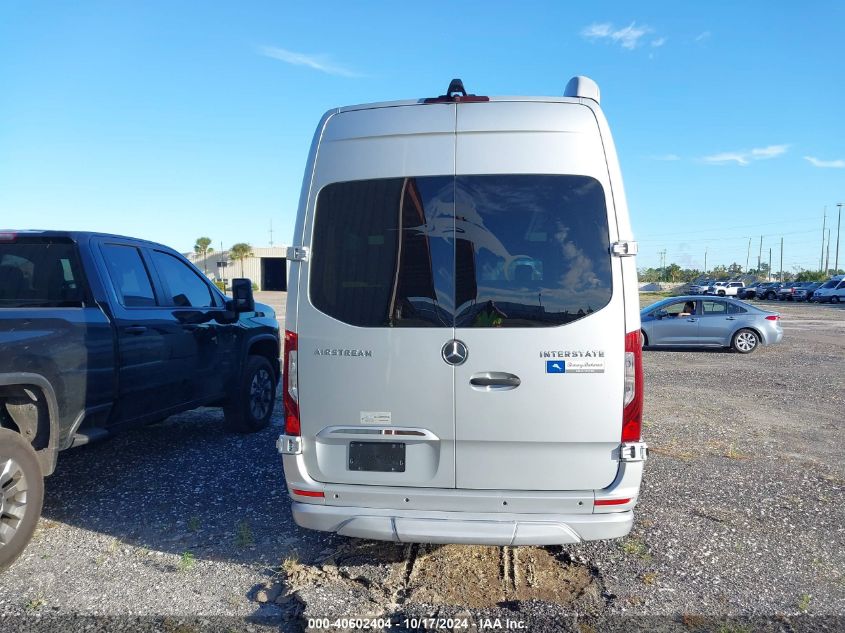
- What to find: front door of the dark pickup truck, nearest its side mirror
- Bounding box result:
[147,248,232,402]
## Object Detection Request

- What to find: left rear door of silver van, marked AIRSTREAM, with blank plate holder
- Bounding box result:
[296,104,455,488]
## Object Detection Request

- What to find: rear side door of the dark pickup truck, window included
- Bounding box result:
[100,239,188,422]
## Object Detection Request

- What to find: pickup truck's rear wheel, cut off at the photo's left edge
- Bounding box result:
[0,429,44,571]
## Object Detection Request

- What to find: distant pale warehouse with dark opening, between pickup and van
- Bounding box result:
[185,246,289,291]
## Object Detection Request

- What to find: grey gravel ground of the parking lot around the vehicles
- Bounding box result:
[0,296,845,631]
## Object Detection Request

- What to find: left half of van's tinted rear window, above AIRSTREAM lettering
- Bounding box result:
[309,176,455,327]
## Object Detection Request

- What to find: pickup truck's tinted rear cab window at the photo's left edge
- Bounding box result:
[0,239,84,308]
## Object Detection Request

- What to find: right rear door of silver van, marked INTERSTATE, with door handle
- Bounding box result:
[455,102,625,490]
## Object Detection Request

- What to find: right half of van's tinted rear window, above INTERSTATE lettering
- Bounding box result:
[455,175,612,327]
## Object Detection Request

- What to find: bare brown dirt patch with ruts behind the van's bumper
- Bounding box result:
[260,541,602,616]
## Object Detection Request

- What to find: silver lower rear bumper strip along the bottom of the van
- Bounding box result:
[291,501,634,545]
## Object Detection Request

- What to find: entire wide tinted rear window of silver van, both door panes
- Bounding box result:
[309,175,612,328]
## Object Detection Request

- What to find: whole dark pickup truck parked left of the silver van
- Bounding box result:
[0,231,280,570]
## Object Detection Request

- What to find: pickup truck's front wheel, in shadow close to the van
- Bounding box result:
[223,356,276,433]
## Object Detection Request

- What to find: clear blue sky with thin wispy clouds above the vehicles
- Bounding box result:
[0,0,845,270]
